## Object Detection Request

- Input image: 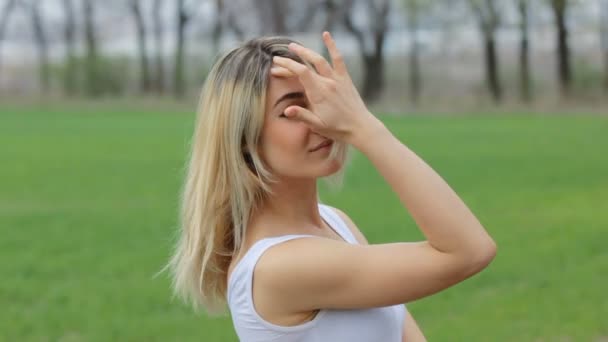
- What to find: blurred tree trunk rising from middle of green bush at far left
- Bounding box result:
[83,0,101,97]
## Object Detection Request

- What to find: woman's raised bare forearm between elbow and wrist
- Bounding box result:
[351,115,496,264]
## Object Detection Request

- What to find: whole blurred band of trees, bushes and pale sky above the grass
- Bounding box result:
[0,0,608,112]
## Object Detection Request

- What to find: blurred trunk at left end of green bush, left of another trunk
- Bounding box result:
[63,0,76,95]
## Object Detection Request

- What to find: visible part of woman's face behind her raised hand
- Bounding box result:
[260,72,341,178]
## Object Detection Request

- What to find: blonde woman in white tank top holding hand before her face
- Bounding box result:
[169,32,496,342]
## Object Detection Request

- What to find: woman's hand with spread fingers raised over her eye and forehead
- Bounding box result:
[271,32,378,148]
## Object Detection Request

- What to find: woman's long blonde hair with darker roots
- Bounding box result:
[165,37,350,314]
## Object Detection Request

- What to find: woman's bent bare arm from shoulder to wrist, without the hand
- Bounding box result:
[255,121,496,312]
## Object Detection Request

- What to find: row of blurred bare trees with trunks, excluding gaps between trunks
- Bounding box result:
[0,0,608,103]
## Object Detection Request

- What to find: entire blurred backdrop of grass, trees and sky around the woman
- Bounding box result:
[0,0,608,341]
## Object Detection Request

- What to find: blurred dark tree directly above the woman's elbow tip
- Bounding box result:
[469,0,502,102]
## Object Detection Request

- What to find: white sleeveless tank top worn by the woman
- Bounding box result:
[227,203,406,342]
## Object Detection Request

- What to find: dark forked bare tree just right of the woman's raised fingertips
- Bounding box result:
[344,0,390,101]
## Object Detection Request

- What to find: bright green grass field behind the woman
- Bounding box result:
[0,105,608,341]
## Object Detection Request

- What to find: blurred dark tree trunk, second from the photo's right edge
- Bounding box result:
[550,0,572,96]
